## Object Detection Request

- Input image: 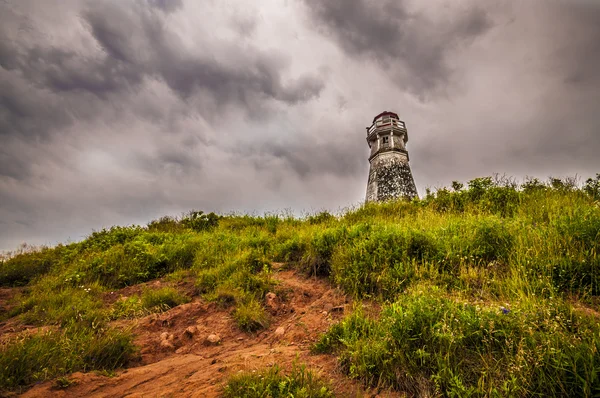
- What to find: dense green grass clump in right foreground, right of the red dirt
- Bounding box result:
[314,286,600,397]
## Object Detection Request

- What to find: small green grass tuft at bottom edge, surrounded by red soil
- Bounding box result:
[223,365,333,398]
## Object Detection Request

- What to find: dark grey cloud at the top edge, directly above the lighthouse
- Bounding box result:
[306,0,492,98]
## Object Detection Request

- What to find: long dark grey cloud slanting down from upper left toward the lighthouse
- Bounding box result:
[85,3,323,110]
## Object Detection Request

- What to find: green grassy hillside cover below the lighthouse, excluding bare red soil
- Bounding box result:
[0,175,600,396]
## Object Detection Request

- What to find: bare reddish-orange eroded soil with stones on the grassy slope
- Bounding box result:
[5,270,402,397]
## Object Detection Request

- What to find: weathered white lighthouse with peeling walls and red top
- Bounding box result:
[366,111,418,202]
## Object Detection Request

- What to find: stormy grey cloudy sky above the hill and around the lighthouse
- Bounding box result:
[0,0,600,250]
